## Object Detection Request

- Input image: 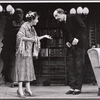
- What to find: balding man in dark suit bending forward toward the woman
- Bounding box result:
[53,8,87,95]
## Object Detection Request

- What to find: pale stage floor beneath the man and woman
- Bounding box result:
[0,84,100,100]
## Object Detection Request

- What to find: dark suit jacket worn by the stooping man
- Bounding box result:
[60,14,87,47]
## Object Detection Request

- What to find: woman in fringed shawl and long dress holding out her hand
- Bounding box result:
[14,11,52,97]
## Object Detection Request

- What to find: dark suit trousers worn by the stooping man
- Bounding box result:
[66,45,86,90]
